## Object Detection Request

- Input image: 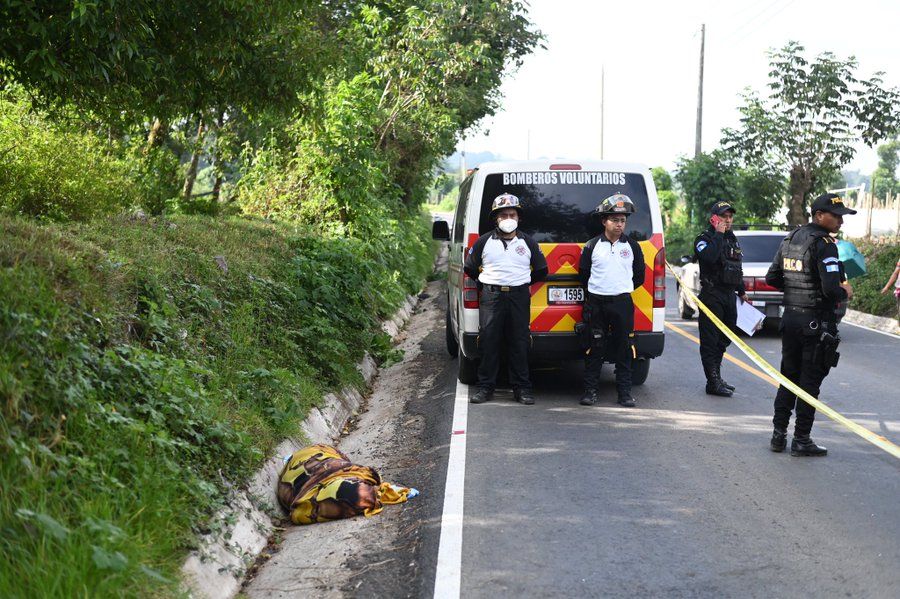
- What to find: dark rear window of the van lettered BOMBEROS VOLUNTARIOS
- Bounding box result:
[478,171,653,243]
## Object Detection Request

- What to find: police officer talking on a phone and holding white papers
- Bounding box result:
[694,201,747,397]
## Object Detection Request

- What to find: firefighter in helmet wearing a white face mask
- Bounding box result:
[464,193,547,405]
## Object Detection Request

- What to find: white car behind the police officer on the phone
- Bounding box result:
[676,225,787,325]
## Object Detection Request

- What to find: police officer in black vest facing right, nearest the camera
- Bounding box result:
[766,193,856,456]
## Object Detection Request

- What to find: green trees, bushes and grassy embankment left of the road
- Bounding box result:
[0,0,540,597]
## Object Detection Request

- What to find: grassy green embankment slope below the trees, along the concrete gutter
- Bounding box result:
[0,216,431,597]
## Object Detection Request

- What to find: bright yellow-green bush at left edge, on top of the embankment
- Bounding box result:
[0,89,140,221]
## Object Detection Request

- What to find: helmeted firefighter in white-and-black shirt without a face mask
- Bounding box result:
[578,193,644,408]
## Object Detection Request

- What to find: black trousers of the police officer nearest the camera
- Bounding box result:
[772,311,830,436]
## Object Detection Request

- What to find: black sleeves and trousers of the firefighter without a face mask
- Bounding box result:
[578,234,645,403]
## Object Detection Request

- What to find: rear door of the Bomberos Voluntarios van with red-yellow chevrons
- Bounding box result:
[479,171,663,333]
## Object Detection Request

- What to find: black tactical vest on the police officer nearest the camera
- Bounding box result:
[781,226,828,310]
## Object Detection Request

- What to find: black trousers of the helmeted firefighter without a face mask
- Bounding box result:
[584,293,634,396]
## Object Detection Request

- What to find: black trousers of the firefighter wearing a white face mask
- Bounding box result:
[478,285,531,391]
